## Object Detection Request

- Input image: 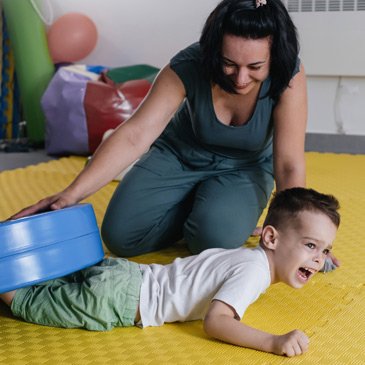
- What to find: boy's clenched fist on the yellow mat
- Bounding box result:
[273,330,309,357]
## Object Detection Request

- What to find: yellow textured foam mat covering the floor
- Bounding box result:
[0,153,365,365]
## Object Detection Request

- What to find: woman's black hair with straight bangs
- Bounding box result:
[200,0,299,100]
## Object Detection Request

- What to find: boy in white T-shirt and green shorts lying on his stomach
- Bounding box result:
[0,188,340,356]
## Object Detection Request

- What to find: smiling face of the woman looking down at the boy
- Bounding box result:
[222,34,271,95]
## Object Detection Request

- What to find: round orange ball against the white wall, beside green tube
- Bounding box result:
[47,13,98,63]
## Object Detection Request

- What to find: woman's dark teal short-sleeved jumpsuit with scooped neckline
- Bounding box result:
[102,43,299,256]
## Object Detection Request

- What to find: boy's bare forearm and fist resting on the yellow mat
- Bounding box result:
[204,300,309,357]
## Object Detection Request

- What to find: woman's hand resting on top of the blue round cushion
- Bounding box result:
[8,191,78,220]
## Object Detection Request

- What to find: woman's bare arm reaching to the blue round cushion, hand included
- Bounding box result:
[11,66,185,219]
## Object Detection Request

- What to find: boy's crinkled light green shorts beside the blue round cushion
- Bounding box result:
[11,258,142,331]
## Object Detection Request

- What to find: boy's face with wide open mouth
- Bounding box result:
[271,211,337,288]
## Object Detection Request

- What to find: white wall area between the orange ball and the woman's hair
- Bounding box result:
[42,0,218,67]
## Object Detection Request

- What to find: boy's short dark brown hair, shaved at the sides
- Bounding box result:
[264,188,341,229]
